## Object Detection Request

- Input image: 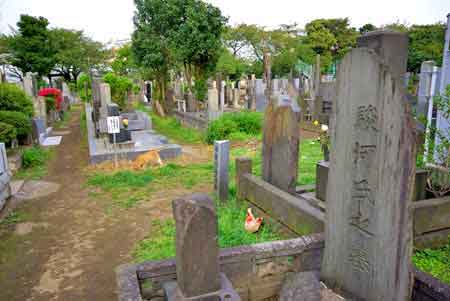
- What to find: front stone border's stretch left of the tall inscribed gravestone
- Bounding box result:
[116,234,324,301]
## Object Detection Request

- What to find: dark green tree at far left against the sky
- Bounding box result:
[8,15,56,76]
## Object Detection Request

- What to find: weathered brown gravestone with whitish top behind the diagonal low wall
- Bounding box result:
[262,95,300,194]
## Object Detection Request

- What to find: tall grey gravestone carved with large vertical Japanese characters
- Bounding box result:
[322,48,416,301]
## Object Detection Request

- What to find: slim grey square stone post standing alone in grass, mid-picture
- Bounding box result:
[214,140,230,201]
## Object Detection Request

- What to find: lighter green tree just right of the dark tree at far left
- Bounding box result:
[50,28,105,82]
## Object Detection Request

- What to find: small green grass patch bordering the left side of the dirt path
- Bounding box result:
[14,146,54,180]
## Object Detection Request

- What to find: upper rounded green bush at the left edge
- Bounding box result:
[0,83,33,117]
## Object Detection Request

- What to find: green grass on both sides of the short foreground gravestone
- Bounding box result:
[133,198,283,262]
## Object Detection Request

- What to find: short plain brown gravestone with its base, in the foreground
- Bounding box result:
[163,194,240,301]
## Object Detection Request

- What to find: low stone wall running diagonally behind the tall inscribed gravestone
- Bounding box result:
[236,158,450,249]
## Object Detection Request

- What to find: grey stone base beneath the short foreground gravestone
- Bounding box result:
[162,273,241,301]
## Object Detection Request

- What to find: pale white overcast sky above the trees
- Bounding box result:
[0,0,450,42]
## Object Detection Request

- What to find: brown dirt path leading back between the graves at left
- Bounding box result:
[0,106,210,301]
